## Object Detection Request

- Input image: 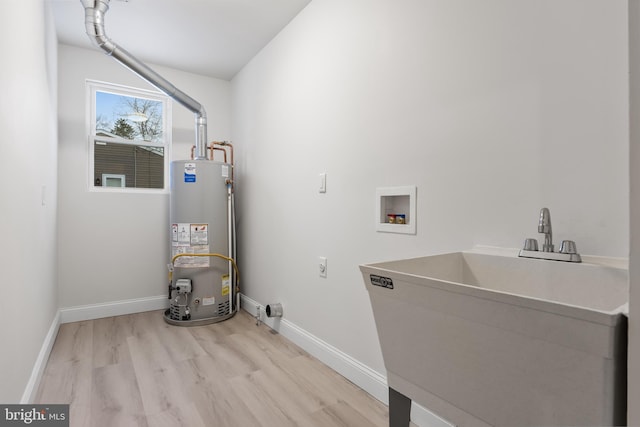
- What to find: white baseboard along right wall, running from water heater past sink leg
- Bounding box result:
[240,294,451,427]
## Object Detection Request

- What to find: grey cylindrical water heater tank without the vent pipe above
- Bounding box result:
[164,160,237,326]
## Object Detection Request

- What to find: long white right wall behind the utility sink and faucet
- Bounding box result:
[232,0,629,382]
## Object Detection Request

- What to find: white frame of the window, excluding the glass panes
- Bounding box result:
[86,80,172,194]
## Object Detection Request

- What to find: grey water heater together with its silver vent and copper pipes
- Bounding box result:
[81,0,239,326]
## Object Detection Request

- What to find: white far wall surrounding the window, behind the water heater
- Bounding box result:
[58,44,230,308]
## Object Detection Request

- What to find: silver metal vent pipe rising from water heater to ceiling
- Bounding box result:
[80,0,207,160]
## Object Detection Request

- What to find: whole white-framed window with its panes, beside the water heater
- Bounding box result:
[87,81,171,191]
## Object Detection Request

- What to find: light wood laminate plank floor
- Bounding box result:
[37,310,400,427]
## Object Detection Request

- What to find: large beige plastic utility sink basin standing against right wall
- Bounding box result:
[360,250,629,426]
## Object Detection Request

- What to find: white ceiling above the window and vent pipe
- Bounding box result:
[48,0,311,80]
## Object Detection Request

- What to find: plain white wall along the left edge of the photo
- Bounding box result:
[0,0,58,403]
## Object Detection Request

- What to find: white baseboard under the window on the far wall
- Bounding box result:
[60,295,169,323]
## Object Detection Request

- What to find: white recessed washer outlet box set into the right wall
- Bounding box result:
[375,185,417,234]
